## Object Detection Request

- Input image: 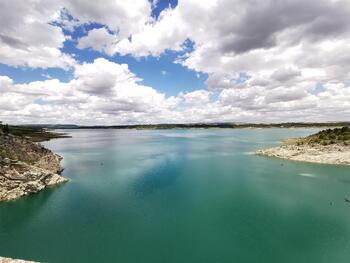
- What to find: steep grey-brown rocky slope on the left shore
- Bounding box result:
[0,133,67,202]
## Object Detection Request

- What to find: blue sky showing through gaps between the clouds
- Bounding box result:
[0,0,207,96]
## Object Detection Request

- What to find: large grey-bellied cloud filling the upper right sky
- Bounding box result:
[98,0,350,98]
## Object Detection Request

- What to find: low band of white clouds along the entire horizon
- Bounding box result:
[0,58,350,124]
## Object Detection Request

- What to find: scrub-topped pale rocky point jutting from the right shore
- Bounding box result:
[256,127,350,165]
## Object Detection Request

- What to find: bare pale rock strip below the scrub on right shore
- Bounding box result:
[256,144,350,165]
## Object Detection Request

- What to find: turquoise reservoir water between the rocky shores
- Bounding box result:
[0,129,350,263]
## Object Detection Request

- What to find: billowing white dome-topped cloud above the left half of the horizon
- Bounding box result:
[0,58,178,124]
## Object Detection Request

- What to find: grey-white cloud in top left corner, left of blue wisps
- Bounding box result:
[0,0,75,69]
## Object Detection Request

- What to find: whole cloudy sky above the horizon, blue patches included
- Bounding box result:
[0,0,350,125]
